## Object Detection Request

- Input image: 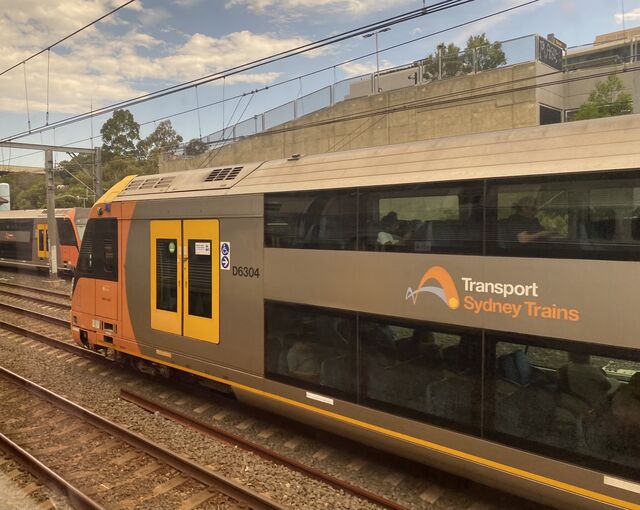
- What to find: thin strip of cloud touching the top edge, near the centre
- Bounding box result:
[227,0,415,18]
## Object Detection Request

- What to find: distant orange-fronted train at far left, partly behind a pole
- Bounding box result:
[0,207,90,272]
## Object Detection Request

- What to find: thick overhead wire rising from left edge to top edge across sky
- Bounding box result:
[0,0,480,142]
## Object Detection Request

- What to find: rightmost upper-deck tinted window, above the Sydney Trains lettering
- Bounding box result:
[487,172,640,260]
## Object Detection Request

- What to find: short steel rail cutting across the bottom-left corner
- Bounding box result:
[0,433,104,510]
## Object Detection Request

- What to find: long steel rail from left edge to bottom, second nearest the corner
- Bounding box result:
[0,367,288,510]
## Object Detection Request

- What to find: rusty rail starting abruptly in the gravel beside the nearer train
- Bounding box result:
[120,388,407,510]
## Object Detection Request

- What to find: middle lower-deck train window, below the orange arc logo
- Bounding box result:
[359,316,482,433]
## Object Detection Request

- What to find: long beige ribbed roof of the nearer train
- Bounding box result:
[115,114,640,201]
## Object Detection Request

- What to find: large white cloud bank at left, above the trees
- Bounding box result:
[0,24,311,117]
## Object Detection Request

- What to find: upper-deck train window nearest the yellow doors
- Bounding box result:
[265,190,357,250]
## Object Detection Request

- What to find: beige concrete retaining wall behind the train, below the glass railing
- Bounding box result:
[160,62,546,173]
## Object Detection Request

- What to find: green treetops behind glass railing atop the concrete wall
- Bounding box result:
[422,34,507,79]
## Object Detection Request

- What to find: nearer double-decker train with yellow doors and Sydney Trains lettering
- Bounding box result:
[72,115,640,509]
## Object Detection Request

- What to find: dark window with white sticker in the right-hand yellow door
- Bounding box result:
[188,239,212,318]
